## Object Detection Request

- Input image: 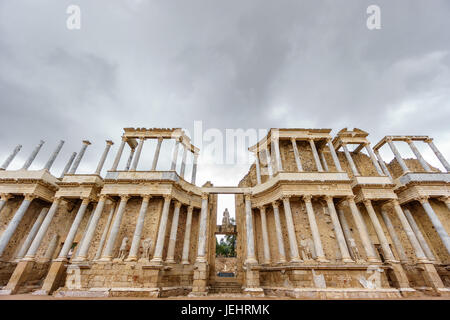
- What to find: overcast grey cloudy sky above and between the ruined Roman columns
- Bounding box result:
[0,0,450,219]
